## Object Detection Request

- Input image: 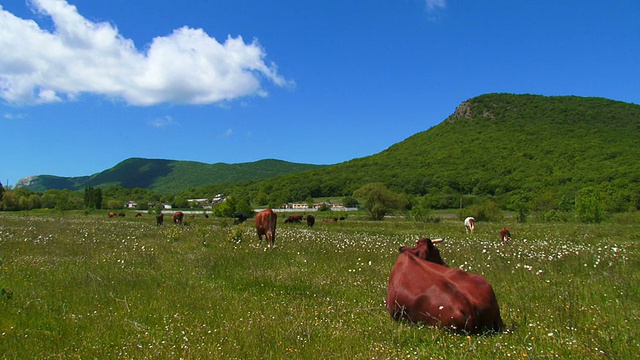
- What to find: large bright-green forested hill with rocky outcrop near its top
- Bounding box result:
[236,94,640,200]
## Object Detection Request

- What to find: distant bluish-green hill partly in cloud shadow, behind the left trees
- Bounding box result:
[16,158,324,193]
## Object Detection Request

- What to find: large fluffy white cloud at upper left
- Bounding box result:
[0,0,292,106]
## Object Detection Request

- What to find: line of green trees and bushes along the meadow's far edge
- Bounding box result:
[0,179,640,223]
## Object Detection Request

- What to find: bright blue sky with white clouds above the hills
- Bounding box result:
[0,0,640,185]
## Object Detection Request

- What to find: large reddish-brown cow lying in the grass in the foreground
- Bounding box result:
[387,238,504,333]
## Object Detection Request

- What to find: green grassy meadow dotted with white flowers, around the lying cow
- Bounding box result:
[0,212,640,359]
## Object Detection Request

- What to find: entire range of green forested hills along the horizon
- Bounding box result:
[16,94,640,202]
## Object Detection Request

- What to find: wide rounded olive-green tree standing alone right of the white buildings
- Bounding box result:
[353,183,407,220]
